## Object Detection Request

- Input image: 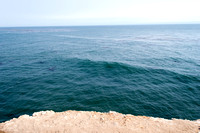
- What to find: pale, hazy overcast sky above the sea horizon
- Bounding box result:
[0,0,200,27]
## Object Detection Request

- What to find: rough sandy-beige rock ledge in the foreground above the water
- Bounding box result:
[0,111,200,133]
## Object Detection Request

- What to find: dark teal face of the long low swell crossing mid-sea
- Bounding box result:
[70,58,200,82]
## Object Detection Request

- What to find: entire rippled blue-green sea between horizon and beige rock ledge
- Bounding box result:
[0,25,200,122]
